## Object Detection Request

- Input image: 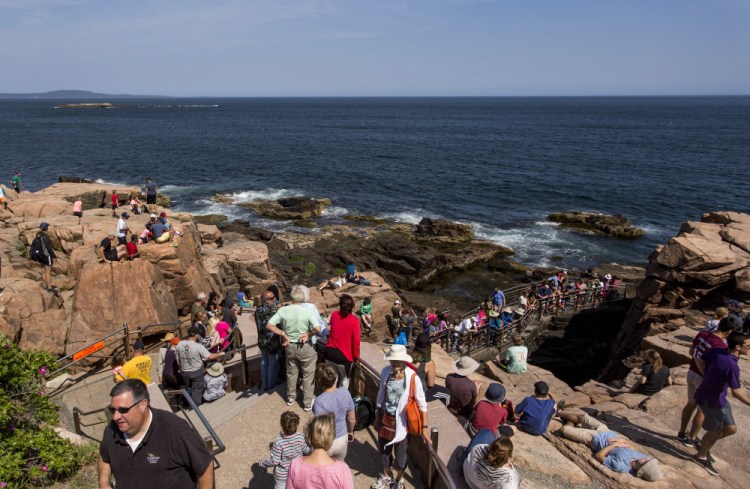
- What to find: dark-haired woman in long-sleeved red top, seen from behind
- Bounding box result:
[325,294,360,377]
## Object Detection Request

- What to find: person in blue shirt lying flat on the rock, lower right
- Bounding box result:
[558,402,662,482]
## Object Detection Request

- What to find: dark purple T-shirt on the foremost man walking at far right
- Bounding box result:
[695,348,740,409]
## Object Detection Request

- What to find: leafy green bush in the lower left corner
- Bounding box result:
[0,335,81,487]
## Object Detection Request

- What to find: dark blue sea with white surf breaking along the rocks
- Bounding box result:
[0,97,750,267]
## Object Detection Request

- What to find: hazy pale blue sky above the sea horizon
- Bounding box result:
[0,0,750,96]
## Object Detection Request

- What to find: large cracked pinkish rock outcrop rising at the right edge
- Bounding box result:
[603,212,750,378]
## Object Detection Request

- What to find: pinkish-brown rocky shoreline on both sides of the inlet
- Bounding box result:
[0,178,750,489]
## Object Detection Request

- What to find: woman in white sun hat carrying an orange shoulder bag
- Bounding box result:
[370,345,430,489]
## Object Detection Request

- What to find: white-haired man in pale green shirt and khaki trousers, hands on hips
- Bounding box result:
[266,285,320,411]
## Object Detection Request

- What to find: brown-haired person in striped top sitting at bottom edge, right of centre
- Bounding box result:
[462,437,521,489]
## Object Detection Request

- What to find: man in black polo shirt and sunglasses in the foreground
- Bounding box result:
[99,379,214,489]
